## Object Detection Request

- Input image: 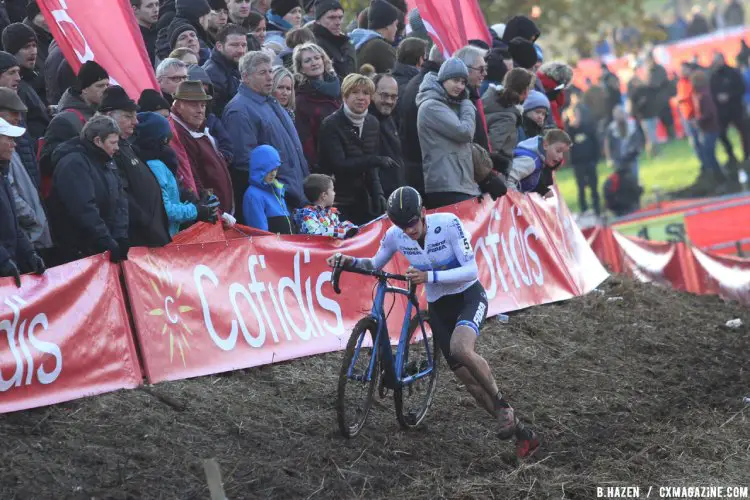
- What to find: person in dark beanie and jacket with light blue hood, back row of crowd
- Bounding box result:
[351,0,403,73]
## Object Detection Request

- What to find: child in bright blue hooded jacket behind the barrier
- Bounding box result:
[242,144,294,234]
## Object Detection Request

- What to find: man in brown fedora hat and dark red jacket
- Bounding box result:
[169,80,234,214]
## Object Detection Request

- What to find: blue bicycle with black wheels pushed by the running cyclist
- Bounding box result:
[331,254,440,438]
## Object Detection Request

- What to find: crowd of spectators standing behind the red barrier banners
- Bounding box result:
[20,0,747,286]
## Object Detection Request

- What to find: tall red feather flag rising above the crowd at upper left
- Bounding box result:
[37,0,159,101]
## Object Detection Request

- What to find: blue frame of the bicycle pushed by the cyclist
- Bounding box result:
[347,277,434,386]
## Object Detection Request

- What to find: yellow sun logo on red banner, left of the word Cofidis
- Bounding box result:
[146,256,193,367]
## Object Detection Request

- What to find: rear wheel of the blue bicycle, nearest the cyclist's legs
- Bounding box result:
[393,312,440,429]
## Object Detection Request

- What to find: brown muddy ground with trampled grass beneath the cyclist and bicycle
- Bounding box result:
[0,278,750,500]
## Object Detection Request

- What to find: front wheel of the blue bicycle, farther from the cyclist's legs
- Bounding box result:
[336,318,380,439]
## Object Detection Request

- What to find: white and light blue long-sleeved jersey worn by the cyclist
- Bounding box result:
[354,213,478,302]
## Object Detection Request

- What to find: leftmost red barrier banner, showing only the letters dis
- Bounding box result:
[0,255,142,413]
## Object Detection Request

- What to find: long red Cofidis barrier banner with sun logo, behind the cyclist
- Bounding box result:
[124,193,607,383]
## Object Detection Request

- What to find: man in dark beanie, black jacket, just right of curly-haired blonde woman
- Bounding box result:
[311,0,357,80]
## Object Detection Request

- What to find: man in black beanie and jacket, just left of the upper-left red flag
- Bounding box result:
[2,23,50,142]
